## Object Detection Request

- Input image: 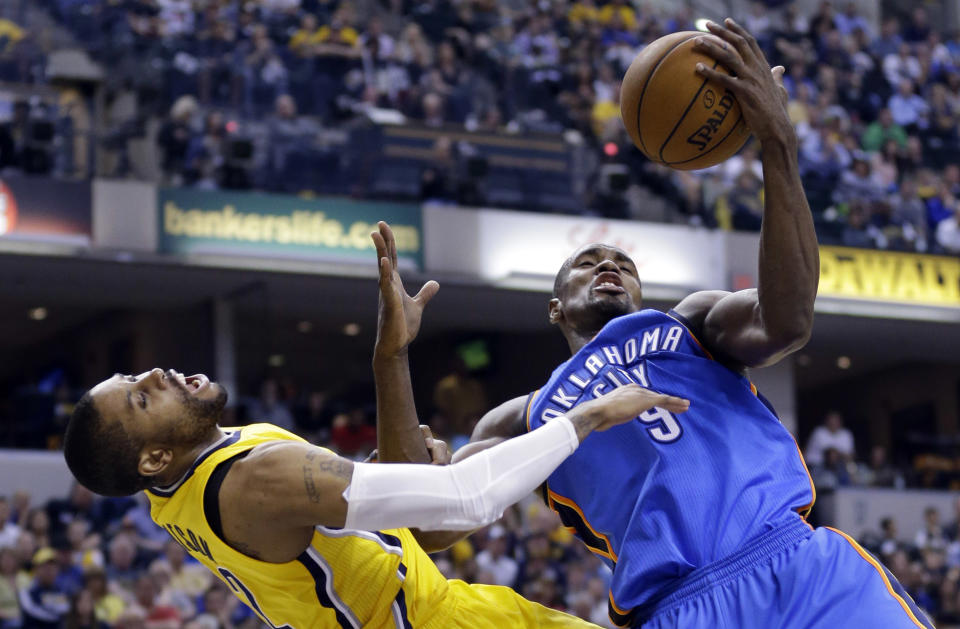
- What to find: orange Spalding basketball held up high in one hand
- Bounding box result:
[620,31,750,170]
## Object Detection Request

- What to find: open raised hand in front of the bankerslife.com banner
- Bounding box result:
[370,221,440,358]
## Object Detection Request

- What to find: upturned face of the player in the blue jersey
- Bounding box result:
[551,244,642,329]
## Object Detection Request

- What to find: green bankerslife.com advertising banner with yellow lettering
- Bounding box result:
[157,188,423,268]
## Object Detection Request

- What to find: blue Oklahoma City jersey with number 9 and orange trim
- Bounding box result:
[527,310,814,623]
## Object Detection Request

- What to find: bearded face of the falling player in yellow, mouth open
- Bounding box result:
[90,368,227,447]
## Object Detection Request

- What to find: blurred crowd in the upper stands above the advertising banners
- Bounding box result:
[0,0,960,253]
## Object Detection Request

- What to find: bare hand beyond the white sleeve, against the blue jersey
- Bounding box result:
[567,384,690,440]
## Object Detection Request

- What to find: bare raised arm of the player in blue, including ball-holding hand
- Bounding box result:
[676,19,820,367]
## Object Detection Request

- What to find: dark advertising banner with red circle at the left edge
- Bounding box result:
[0,176,91,242]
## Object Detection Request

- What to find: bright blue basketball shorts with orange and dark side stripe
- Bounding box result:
[635,518,933,629]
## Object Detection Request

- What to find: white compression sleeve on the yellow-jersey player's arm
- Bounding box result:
[343,416,580,531]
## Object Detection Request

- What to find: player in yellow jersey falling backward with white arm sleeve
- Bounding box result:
[64,226,687,629]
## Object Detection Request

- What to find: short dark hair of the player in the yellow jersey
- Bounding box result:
[63,392,151,496]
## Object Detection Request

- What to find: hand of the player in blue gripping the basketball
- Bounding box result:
[694,18,796,145]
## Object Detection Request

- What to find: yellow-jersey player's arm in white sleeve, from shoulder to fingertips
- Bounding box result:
[220,385,689,561]
